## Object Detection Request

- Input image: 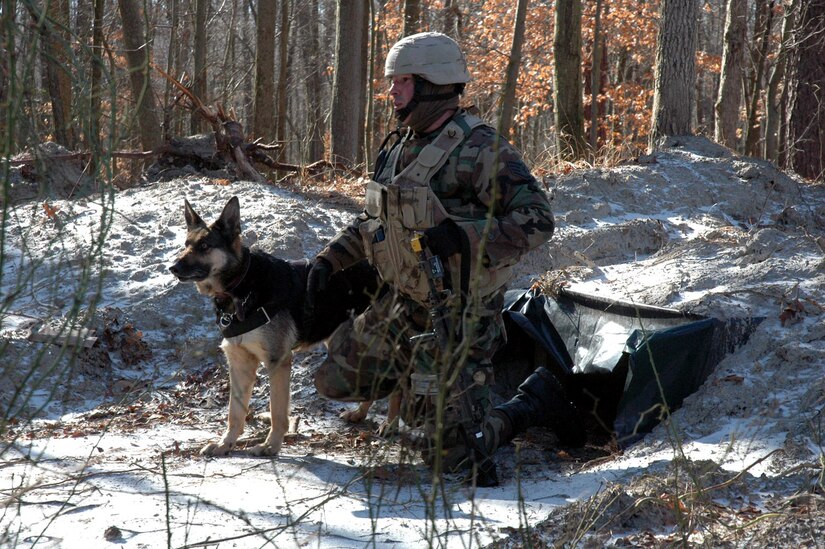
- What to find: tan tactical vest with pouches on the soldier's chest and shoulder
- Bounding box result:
[359,112,512,304]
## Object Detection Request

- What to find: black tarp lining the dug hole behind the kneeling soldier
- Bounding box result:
[494,290,762,443]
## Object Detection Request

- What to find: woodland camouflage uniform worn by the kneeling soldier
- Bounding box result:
[316,111,554,409]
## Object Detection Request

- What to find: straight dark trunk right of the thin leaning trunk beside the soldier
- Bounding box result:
[553,0,587,160]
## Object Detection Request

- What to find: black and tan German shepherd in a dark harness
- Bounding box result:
[169,197,380,456]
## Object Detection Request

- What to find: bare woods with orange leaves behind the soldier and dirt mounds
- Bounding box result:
[0,0,825,186]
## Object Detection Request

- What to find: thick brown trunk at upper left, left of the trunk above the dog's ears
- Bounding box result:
[41,0,74,149]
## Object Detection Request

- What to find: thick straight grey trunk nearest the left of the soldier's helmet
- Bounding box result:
[330,0,366,164]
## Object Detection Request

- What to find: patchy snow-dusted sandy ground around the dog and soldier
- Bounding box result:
[0,138,825,549]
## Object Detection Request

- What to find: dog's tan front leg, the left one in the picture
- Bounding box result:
[200,341,259,456]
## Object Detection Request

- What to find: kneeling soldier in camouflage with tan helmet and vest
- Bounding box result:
[306,32,554,470]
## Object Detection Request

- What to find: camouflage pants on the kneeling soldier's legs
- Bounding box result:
[315,290,506,409]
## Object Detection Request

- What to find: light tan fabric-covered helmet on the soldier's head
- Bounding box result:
[384,32,470,85]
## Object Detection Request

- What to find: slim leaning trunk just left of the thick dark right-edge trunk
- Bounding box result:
[765,0,799,164]
